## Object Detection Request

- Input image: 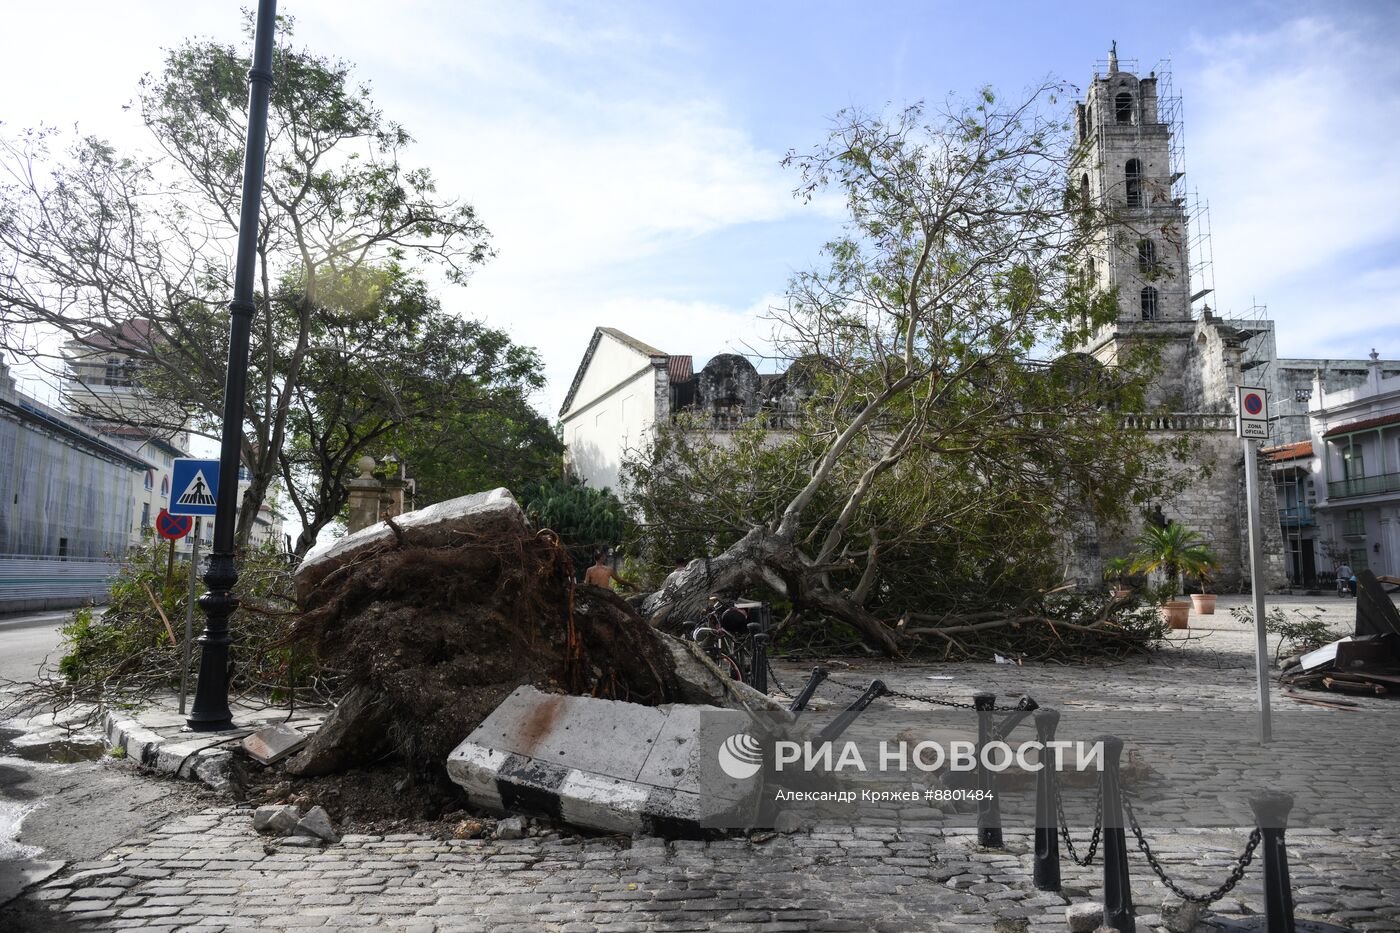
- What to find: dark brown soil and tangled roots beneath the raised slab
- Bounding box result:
[295,534,678,769]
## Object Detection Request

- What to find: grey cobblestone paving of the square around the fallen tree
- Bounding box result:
[10,600,1400,933]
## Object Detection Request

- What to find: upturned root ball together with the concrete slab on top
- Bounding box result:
[287,489,711,776]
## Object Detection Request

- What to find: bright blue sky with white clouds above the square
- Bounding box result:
[0,0,1400,413]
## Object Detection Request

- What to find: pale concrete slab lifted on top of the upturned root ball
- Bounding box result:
[293,488,529,605]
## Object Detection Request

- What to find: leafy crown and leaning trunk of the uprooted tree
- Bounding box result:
[626,85,1187,654]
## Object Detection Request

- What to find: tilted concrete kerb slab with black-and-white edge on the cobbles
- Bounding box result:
[447,686,762,836]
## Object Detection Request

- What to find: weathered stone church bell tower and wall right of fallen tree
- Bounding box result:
[1067,49,1394,593]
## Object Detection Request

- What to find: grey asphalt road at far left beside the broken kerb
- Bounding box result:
[0,602,210,913]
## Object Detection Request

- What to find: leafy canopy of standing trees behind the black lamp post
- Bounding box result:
[0,18,547,545]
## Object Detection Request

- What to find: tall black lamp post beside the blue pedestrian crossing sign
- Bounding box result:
[185,0,277,731]
